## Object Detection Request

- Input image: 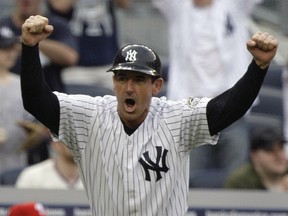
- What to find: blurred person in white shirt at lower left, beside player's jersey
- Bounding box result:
[16,141,83,189]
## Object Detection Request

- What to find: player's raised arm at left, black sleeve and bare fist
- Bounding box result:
[21,15,60,134]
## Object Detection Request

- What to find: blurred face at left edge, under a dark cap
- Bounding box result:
[0,44,20,70]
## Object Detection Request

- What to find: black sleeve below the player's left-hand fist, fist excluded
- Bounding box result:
[21,44,60,134]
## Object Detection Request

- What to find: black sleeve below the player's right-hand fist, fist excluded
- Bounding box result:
[207,61,268,135]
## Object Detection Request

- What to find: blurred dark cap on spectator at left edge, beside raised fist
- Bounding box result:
[0,26,20,49]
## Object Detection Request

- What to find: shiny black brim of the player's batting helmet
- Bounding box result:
[107,62,159,76]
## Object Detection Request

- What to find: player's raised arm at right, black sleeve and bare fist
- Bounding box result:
[207,32,278,135]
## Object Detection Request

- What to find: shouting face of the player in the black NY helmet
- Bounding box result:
[113,71,163,128]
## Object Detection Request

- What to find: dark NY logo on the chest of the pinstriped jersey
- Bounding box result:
[139,146,169,181]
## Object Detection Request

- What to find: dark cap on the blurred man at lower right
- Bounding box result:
[250,127,286,150]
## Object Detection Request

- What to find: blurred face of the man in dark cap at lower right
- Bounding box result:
[251,144,288,175]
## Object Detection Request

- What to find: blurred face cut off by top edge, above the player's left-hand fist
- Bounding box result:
[15,0,42,19]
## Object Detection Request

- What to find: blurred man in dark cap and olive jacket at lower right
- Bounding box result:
[225,127,288,191]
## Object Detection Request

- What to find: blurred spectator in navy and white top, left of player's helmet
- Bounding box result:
[47,0,131,90]
